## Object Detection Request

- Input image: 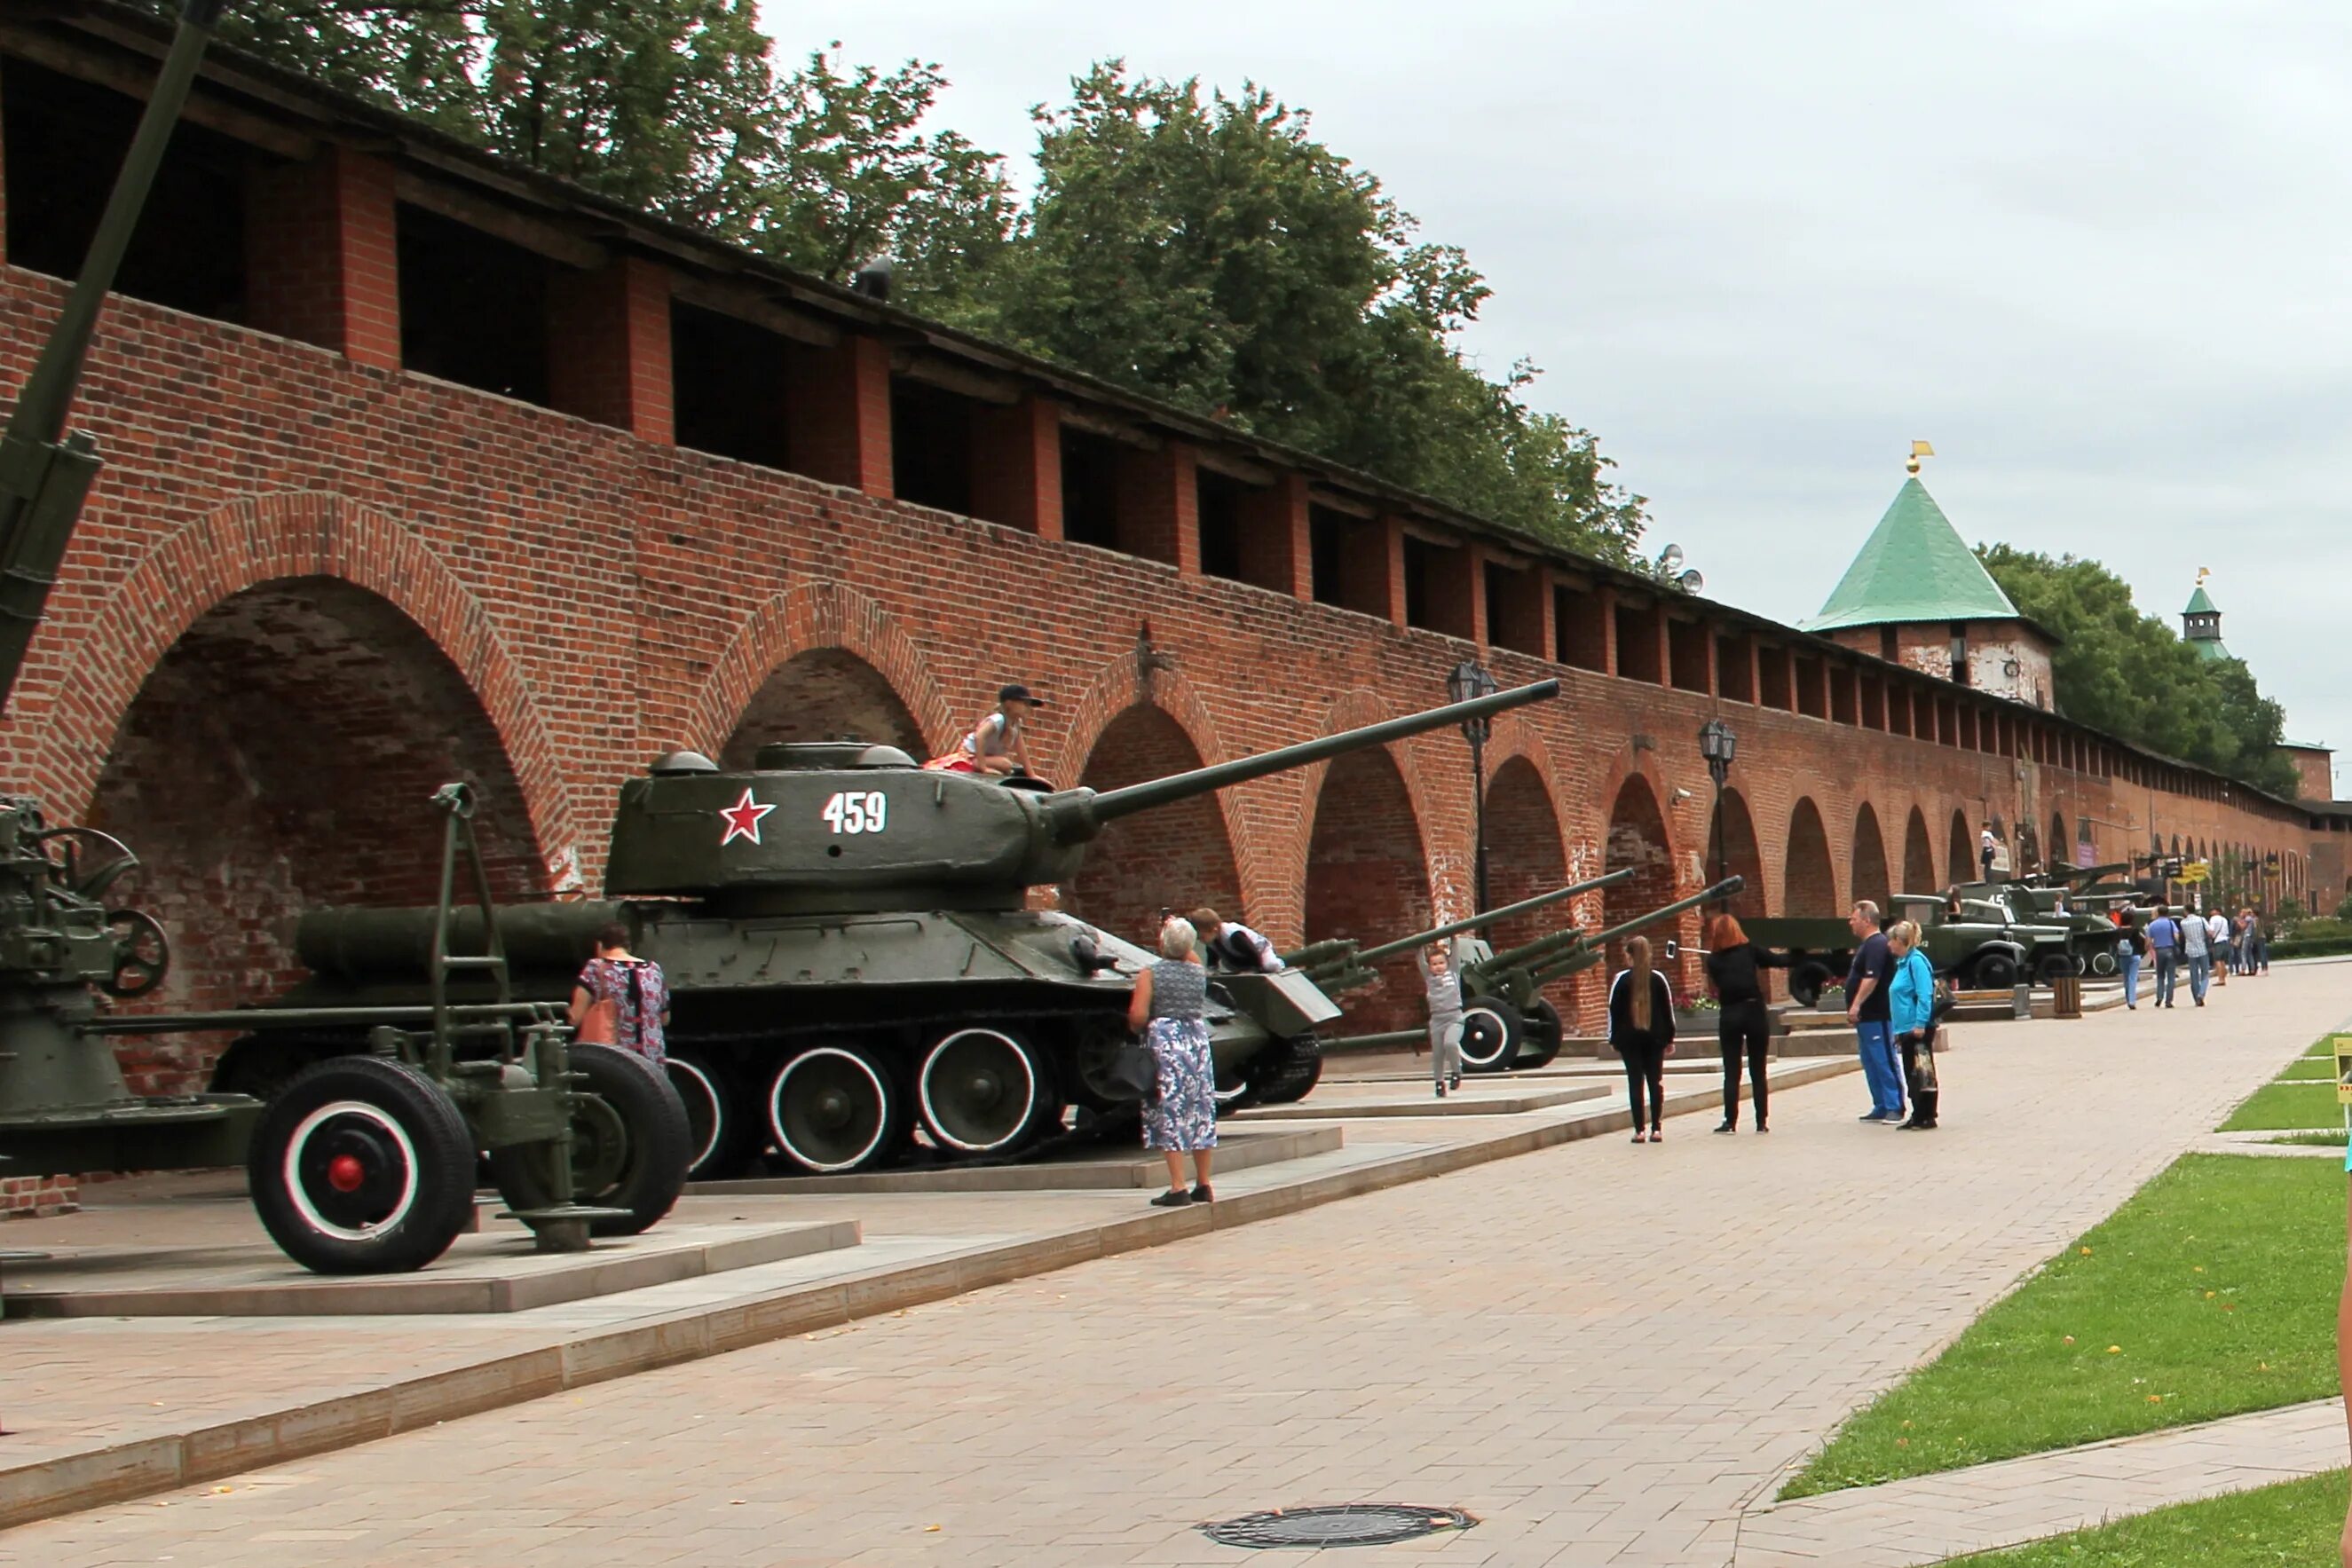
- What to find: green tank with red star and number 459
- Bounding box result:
[214,682,1559,1178]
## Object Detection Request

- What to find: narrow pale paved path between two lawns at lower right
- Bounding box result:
[1736,1399,2345,1568]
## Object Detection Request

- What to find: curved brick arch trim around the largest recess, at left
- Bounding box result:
[33,492,573,879]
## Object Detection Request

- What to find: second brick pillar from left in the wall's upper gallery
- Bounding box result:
[548,256,677,446]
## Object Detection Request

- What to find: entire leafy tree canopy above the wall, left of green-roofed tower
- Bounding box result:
[144,0,1646,564]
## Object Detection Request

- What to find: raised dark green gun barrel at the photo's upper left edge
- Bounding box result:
[0,0,221,707]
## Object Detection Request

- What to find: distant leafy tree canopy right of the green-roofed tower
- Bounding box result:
[1976,546,2295,800]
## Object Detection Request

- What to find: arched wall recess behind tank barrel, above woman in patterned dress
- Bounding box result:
[1063,705,1251,952]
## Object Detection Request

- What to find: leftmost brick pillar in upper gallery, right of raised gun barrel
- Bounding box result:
[245,148,400,369]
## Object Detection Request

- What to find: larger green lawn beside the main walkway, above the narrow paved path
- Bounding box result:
[1780,1154,2345,1504]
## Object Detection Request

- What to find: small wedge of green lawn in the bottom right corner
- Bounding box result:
[1943,1470,2345,1568]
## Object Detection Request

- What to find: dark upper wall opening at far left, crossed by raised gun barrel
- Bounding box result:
[0,57,261,322]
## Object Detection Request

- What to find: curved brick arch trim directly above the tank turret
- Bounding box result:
[683,579,959,757]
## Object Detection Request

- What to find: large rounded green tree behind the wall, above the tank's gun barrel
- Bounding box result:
[938,61,1642,560]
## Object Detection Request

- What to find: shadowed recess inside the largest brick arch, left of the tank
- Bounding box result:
[90,579,546,1093]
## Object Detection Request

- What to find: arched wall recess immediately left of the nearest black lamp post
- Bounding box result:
[1306,750,1437,1036]
